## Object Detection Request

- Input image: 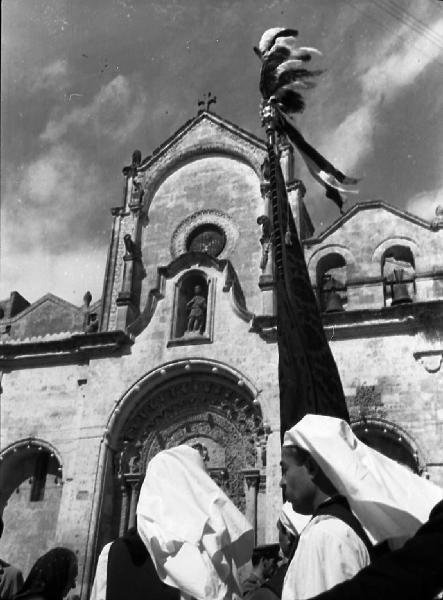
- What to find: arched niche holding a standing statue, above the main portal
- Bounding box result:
[173,271,208,339]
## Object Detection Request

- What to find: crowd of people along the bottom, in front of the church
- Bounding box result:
[0,415,443,600]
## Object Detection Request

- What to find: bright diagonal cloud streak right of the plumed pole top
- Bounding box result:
[323,18,443,172]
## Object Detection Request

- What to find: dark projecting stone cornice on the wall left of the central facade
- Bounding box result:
[0,331,133,368]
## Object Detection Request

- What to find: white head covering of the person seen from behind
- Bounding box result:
[137,446,254,600]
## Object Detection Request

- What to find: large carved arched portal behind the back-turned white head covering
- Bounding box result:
[100,360,267,540]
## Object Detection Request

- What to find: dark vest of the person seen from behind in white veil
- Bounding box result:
[106,531,180,600]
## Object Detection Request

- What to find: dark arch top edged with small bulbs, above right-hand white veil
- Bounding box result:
[353,423,419,473]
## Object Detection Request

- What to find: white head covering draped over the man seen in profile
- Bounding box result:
[283,415,443,542]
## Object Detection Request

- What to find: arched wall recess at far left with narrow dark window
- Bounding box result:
[0,438,63,573]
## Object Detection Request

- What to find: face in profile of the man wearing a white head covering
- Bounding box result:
[280,446,317,515]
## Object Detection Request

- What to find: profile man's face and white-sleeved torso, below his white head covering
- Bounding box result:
[280,426,371,600]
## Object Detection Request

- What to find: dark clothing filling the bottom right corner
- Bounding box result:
[310,501,443,600]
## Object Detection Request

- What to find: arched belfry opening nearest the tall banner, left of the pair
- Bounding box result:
[316,252,347,312]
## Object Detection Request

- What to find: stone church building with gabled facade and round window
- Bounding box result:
[0,112,443,597]
